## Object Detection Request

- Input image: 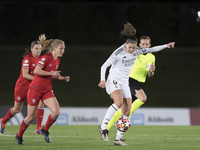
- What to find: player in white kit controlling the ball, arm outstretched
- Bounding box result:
[98,22,175,145]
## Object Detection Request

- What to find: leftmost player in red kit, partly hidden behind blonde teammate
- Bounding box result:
[0,41,44,134]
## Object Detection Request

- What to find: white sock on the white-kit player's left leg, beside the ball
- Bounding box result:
[101,104,119,130]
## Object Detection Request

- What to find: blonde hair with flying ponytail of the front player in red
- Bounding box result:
[39,34,65,52]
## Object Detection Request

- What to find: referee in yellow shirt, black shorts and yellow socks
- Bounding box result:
[107,36,155,145]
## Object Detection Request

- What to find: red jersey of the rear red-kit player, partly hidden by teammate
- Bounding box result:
[15,52,42,89]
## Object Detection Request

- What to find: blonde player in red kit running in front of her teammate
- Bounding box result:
[15,34,70,145]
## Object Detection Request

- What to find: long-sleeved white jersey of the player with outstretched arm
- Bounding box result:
[101,44,167,81]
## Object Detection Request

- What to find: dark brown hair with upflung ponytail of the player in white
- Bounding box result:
[120,22,138,44]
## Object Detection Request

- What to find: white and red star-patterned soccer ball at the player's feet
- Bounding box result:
[116,117,131,132]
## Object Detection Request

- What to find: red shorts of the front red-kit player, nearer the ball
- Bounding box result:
[27,88,55,106]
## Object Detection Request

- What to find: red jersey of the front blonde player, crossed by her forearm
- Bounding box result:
[30,52,60,93]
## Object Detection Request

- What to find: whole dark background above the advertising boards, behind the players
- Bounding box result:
[0,1,200,107]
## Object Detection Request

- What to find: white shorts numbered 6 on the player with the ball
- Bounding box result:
[106,78,132,98]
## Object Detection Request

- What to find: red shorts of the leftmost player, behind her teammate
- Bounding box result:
[14,87,28,103]
